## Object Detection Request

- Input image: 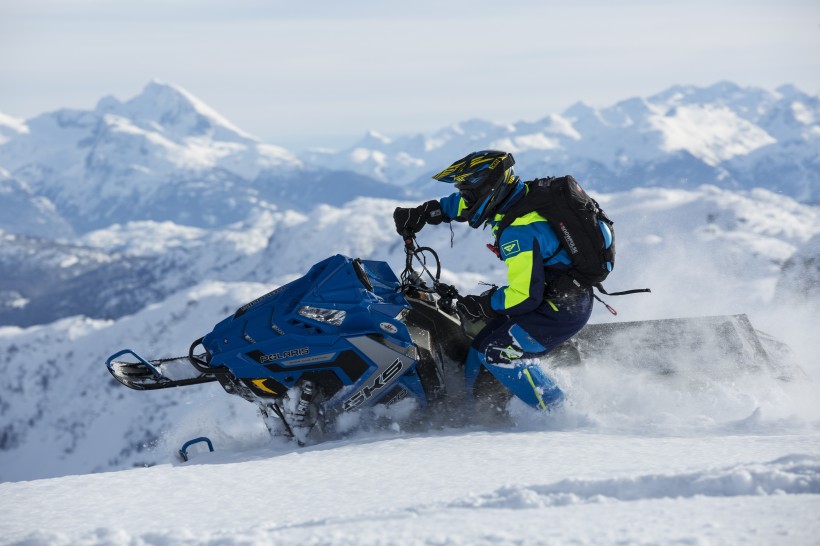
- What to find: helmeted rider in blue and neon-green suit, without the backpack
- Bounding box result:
[393,150,592,410]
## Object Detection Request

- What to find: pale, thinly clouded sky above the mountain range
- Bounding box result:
[0,0,820,150]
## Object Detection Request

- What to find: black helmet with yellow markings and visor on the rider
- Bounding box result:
[433,150,518,228]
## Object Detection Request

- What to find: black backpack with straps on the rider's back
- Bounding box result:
[495,175,649,310]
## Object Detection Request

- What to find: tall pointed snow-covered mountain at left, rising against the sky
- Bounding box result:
[0,81,396,235]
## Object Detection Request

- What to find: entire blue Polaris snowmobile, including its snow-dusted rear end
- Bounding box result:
[106,238,800,444]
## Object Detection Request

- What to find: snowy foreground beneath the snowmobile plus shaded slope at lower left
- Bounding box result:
[0,258,820,545]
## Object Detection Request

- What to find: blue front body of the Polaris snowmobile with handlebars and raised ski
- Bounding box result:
[106,238,540,443]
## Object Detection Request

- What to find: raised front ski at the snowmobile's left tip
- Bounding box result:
[105,349,217,391]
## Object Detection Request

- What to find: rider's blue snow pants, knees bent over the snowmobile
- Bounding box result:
[464,291,593,409]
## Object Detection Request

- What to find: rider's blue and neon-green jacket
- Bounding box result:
[439,187,572,315]
